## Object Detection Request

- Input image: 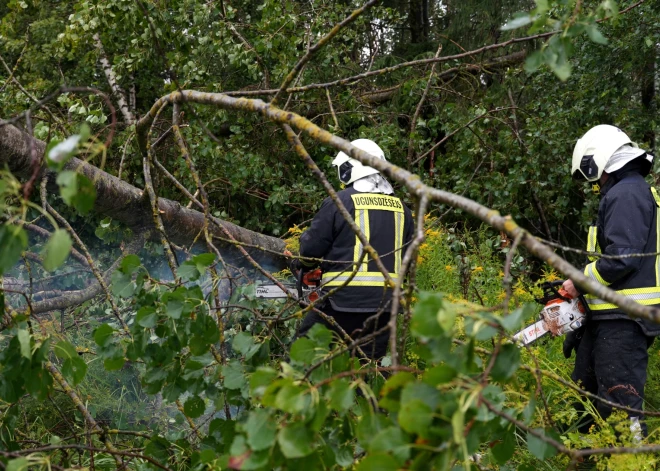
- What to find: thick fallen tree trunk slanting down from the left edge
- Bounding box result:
[0,123,284,266]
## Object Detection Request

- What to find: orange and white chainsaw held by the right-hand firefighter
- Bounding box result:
[513,281,587,345]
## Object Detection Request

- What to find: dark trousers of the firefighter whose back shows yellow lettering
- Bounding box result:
[298,303,390,360]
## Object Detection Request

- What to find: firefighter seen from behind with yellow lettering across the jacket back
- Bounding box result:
[298,139,413,359]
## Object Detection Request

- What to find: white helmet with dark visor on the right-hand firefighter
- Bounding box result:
[571,124,644,182]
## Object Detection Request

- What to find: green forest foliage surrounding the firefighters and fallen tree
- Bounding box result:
[0,0,660,471]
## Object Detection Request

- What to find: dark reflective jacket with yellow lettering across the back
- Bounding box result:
[300,186,413,312]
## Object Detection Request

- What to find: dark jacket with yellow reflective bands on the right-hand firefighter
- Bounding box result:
[584,172,660,336]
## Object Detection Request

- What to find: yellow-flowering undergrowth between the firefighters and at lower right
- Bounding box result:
[416,215,660,471]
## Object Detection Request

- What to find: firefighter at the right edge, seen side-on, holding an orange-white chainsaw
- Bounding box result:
[564,125,660,441]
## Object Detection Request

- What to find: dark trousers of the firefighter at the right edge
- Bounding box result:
[571,319,654,435]
